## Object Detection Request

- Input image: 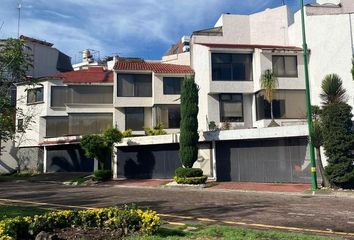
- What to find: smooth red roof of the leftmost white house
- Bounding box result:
[49,67,113,83]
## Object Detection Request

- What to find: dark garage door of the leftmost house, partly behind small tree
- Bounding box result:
[47,144,93,172]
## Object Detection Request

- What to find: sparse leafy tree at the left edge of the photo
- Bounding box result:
[0,38,34,159]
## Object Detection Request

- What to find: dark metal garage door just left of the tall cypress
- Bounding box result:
[117,144,181,178]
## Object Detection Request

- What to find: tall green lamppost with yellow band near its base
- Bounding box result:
[300,0,317,191]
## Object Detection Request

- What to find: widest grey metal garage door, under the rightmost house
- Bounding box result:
[216,138,310,183]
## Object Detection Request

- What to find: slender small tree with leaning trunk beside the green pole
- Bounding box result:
[310,120,331,187]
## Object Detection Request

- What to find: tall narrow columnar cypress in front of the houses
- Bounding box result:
[179,77,199,168]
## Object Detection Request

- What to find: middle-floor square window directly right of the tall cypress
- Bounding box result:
[220,94,243,122]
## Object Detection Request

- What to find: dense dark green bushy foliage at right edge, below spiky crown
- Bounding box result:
[321,102,354,188]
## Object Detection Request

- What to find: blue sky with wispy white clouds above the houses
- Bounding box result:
[0,0,314,63]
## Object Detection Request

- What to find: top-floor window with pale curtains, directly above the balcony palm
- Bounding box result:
[272,56,298,77]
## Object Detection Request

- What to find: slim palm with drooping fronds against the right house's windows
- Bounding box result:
[261,69,278,127]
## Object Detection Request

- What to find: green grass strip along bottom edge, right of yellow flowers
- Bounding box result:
[127,225,337,240]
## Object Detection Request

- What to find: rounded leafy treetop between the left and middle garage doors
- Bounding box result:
[80,134,107,160]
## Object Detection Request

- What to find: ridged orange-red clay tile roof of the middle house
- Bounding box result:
[114,62,194,74]
